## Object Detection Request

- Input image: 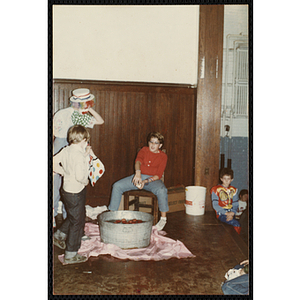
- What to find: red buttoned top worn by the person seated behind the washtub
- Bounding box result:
[135,146,168,179]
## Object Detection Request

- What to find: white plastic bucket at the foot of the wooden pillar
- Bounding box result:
[185,186,206,216]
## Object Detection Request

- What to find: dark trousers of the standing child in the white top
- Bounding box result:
[59,187,86,252]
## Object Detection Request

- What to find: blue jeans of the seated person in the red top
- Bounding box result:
[108,174,169,212]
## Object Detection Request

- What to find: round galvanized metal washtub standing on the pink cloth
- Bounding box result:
[97,210,153,249]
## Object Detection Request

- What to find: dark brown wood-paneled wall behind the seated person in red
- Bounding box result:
[52,79,196,206]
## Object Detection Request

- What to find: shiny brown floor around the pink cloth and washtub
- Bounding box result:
[49,211,248,295]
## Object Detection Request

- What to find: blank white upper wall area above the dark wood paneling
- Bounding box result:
[53,5,199,85]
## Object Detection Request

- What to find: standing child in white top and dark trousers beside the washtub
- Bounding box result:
[53,125,94,264]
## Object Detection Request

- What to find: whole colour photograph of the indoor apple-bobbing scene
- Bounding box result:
[48,1,254,298]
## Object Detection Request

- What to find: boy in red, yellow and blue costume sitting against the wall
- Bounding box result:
[211,168,241,234]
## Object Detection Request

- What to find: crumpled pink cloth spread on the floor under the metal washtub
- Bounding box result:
[58,223,195,264]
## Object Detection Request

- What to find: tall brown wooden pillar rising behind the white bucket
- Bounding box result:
[195,5,224,210]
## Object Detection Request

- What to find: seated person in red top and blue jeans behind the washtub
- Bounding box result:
[108,132,169,230]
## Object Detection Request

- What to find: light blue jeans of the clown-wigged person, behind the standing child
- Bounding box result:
[53,137,68,219]
